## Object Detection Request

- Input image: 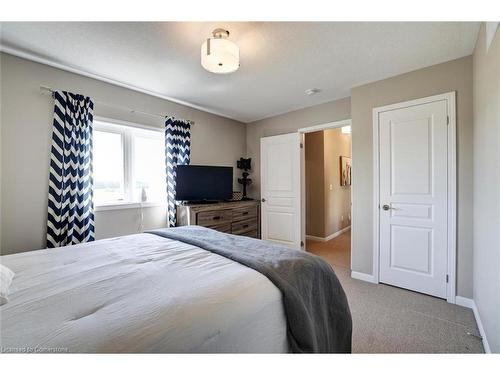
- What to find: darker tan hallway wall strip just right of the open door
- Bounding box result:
[304,131,326,237]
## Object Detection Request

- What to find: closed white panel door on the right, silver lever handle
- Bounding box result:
[378,100,448,298]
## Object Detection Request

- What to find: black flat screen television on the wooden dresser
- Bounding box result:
[175,165,233,201]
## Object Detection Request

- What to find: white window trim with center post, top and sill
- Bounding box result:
[93,116,167,211]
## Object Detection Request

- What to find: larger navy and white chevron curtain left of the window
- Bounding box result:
[47,91,94,248]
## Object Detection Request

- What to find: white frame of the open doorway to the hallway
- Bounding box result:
[297,118,353,262]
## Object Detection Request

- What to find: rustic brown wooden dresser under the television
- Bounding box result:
[177,201,260,238]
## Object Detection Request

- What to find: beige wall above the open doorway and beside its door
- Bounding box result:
[246,98,351,198]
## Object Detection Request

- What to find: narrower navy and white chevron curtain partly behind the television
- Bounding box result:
[165,117,191,227]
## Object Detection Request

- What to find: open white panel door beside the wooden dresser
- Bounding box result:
[260,133,301,248]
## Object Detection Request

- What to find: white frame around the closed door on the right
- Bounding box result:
[373,91,457,303]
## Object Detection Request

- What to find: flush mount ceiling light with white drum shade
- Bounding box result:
[201,29,240,74]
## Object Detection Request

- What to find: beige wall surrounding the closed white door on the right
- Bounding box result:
[351,56,473,297]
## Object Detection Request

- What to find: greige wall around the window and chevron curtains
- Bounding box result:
[0,53,246,254]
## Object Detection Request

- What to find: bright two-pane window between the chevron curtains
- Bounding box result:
[93,121,166,207]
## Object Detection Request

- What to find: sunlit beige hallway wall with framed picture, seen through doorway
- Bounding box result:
[324,129,351,237]
